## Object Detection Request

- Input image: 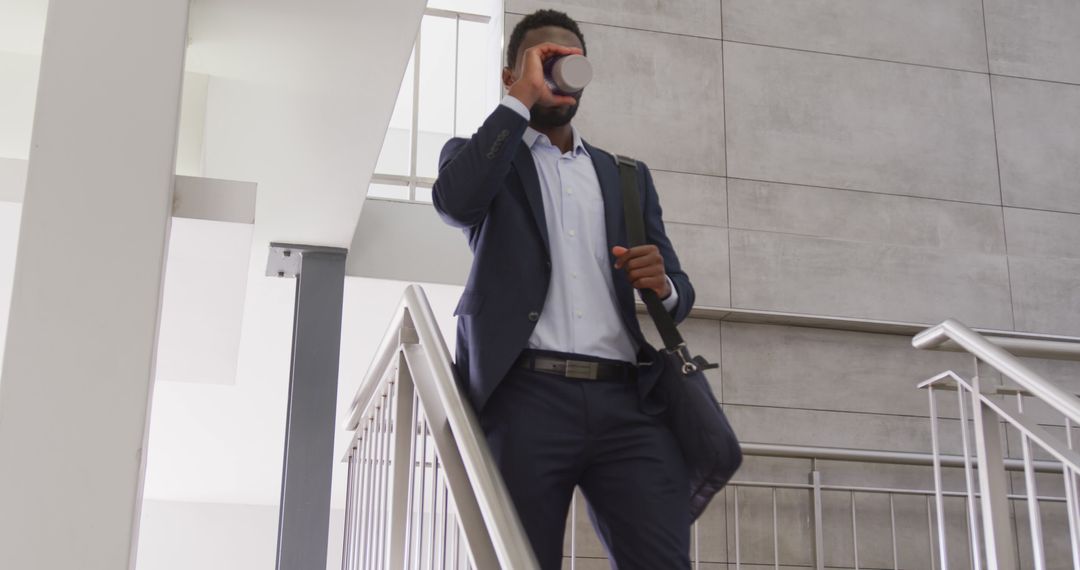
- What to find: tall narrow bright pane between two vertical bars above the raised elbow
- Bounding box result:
[416,16,457,178]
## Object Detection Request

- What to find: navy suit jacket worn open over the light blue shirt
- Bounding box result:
[432,105,694,412]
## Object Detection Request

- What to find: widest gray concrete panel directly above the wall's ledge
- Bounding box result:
[729,230,1012,328]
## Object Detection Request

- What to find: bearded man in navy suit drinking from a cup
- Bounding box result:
[432,11,694,570]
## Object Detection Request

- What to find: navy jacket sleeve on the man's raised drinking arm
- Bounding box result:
[431,105,528,228]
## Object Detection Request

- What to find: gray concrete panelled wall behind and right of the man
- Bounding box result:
[505,0,1080,569]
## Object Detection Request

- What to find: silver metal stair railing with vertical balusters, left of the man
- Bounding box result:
[342,285,539,570]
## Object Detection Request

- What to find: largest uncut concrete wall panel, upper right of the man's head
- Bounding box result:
[725,43,1000,204]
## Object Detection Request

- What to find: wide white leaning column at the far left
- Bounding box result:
[0,0,188,570]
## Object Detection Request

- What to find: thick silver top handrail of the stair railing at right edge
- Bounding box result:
[912,318,1080,423]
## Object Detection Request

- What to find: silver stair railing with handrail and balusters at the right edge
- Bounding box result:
[912,318,1080,570]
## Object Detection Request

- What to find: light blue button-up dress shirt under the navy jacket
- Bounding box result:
[502,95,678,363]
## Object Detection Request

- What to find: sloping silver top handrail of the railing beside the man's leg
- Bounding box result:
[346,285,539,570]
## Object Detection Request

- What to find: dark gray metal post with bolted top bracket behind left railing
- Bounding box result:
[267,244,347,570]
